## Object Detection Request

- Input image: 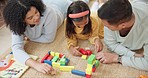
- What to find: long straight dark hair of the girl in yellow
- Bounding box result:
[66,1,92,38]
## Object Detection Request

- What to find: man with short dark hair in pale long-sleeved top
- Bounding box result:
[97,0,148,71]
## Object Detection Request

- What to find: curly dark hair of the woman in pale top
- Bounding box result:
[3,0,45,35]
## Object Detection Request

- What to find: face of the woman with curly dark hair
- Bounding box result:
[25,6,40,25]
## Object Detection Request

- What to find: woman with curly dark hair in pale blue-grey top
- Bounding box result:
[3,0,70,73]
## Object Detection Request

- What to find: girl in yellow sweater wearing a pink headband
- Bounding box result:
[65,1,103,56]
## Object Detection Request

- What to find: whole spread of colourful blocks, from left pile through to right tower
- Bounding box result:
[41,51,99,78]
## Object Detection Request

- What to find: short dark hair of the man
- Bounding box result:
[98,0,132,25]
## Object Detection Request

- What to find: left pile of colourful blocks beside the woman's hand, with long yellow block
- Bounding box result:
[41,51,74,72]
